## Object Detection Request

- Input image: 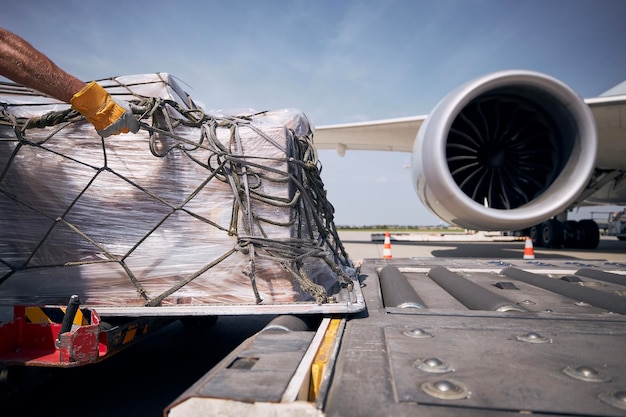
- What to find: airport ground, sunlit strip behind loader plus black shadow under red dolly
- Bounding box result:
[0,231,626,417]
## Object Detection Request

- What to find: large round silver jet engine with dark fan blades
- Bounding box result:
[412,71,598,231]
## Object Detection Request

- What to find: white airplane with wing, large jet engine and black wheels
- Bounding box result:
[314,70,626,247]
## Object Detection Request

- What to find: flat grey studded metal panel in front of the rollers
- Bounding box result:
[385,315,626,416]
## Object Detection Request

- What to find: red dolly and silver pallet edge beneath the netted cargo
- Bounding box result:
[0,276,365,368]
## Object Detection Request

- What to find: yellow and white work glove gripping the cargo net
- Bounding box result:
[70,81,139,138]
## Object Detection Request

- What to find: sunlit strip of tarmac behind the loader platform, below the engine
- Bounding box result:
[339,230,626,263]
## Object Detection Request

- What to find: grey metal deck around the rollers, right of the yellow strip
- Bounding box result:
[324,258,626,417]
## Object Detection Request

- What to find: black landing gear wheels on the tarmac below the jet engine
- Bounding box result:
[527,219,600,249]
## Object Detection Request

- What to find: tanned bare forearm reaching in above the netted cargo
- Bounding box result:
[0,28,86,103]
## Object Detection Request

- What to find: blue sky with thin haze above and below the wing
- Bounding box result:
[0,0,626,225]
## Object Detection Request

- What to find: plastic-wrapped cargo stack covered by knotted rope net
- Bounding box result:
[0,74,354,306]
